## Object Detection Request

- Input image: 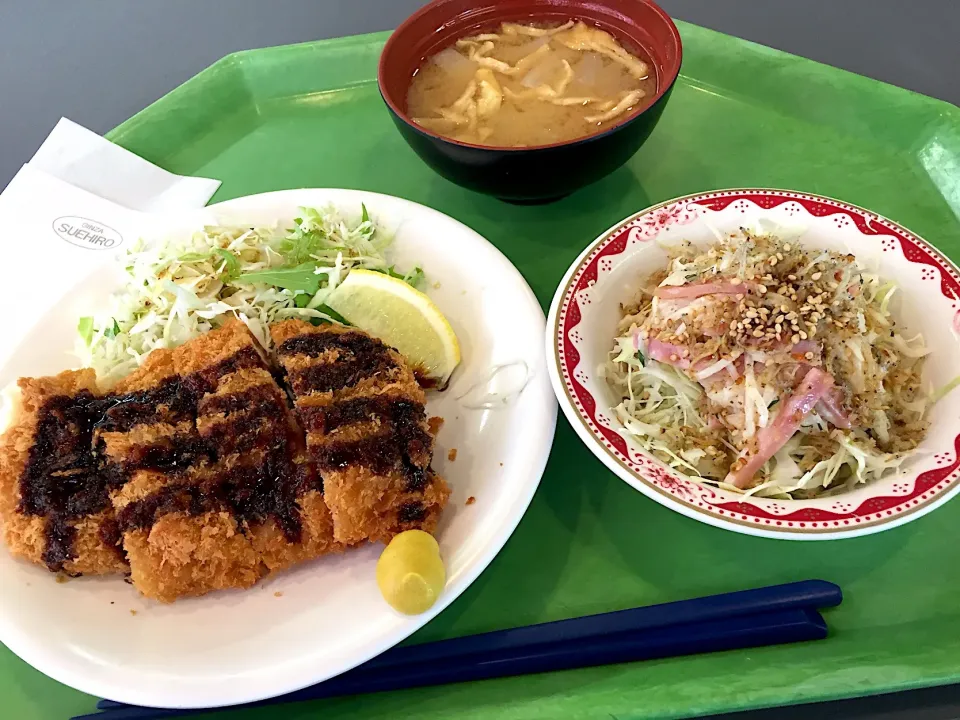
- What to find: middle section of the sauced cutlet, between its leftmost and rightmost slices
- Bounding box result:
[98,322,339,601]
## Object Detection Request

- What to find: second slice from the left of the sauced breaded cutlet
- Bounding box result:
[97,336,263,602]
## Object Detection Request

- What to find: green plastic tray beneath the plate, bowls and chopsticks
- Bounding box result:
[7,23,960,720]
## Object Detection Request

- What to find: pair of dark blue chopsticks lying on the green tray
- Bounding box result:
[84,580,842,720]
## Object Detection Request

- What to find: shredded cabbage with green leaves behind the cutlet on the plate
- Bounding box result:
[76,202,423,386]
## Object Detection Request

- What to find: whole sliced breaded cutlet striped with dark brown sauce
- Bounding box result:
[0,321,450,602]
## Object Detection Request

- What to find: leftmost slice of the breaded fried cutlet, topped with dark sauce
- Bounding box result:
[0,370,127,575]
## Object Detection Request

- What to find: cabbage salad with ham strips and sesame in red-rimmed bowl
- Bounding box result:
[600,229,942,499]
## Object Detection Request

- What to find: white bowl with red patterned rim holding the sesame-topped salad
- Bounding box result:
[546,190,960,540]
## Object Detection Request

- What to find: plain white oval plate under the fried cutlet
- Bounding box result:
[0,189,557,708]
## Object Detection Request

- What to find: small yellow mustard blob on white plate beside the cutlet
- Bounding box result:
[377,530,447,615]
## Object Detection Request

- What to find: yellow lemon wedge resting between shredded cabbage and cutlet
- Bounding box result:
[326,269,460,386]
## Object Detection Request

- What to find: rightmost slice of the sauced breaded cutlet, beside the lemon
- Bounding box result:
[271,320,450,545]
